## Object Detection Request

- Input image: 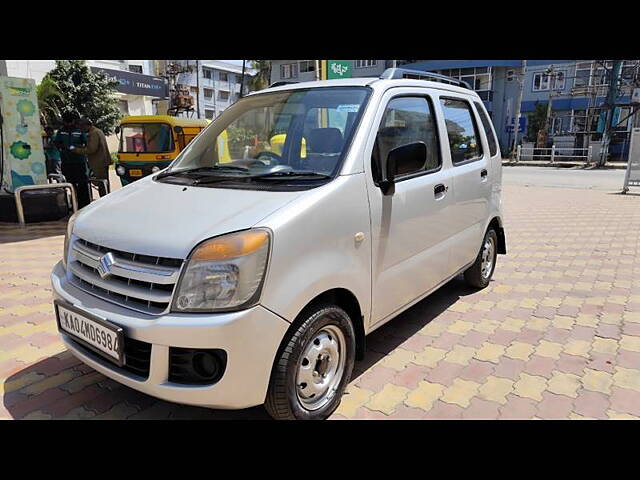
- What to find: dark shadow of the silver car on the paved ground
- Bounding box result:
[3,277,476,420]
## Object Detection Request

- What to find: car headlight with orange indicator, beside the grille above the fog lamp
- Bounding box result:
[173,229,271,312]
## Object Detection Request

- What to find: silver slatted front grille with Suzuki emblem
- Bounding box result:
[69,239,183,315]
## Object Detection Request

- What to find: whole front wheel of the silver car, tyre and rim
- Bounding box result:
[265,304,355,420]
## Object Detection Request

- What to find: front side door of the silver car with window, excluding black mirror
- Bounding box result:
[367,89,453,325]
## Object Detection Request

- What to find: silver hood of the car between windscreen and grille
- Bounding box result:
[73,177,302,258]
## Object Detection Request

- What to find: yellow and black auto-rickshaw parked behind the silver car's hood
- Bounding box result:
[115,115,210,186]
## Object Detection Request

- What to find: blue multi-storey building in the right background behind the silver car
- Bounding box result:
[402,60,640,160]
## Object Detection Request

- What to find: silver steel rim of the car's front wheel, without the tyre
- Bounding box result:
[295,325,346,410]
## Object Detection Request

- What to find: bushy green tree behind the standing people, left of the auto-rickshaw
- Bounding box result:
[43,60,122,135]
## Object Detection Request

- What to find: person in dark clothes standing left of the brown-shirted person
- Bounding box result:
[54,113,91,208]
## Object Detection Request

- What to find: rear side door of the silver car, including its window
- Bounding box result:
[438,92,491,271]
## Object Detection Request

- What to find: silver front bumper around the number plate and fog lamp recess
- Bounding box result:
[51,262,289,409]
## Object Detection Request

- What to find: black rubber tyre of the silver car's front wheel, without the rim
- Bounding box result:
[264,304,356,420]
